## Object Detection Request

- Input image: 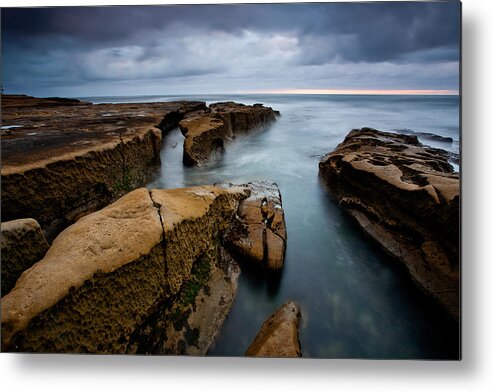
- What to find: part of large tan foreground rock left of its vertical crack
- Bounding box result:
[2,188,166,353]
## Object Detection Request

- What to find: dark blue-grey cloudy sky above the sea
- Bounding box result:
[1,1,460,97]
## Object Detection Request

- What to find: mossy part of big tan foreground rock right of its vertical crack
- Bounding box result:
[136,186,248,355]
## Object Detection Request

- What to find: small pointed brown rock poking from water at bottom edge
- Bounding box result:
[245,302,301,358]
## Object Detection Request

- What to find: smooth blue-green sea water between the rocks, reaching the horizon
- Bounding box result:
[81,95,460,359]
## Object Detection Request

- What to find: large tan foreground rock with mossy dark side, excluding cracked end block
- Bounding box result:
[2,186,248,353]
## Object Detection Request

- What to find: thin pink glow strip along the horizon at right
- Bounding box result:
[242,89,459,95]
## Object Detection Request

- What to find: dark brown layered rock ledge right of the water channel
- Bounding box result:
[319,128,460,320]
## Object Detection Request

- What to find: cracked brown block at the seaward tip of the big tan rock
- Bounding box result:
[219,181,287,270]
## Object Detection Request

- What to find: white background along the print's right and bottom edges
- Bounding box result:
[0,0,493,392]
